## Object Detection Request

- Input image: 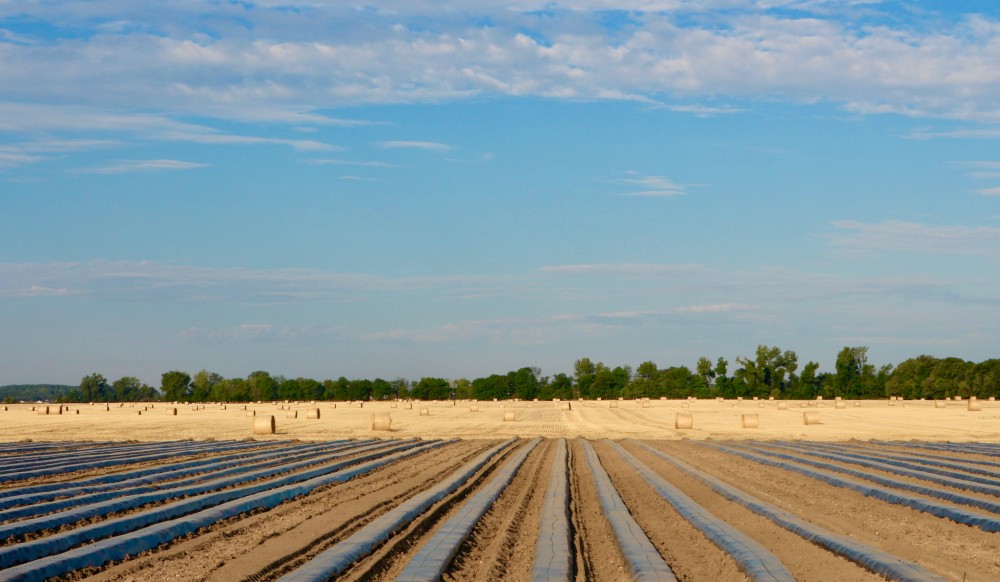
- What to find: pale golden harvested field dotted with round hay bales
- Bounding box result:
[0,400,1000,442]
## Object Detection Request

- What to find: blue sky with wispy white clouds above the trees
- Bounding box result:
[0,0,1000,385]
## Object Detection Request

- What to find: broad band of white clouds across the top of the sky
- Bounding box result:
[0,0,1000,145]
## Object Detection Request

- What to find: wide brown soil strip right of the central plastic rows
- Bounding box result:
[649,441,1000,582]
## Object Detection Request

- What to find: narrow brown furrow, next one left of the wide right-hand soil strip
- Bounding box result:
[601,442,882,582]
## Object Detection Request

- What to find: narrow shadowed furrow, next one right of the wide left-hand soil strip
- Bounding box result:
[330,438,538,582]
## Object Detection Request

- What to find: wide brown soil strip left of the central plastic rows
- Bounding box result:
[88,441,496,581]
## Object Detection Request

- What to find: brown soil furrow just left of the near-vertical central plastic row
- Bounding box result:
[442,439,556,582]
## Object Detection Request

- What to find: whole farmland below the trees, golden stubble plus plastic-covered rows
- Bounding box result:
[0,401,1000,581]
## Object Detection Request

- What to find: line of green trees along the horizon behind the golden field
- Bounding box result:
[54,345,1000,402]
